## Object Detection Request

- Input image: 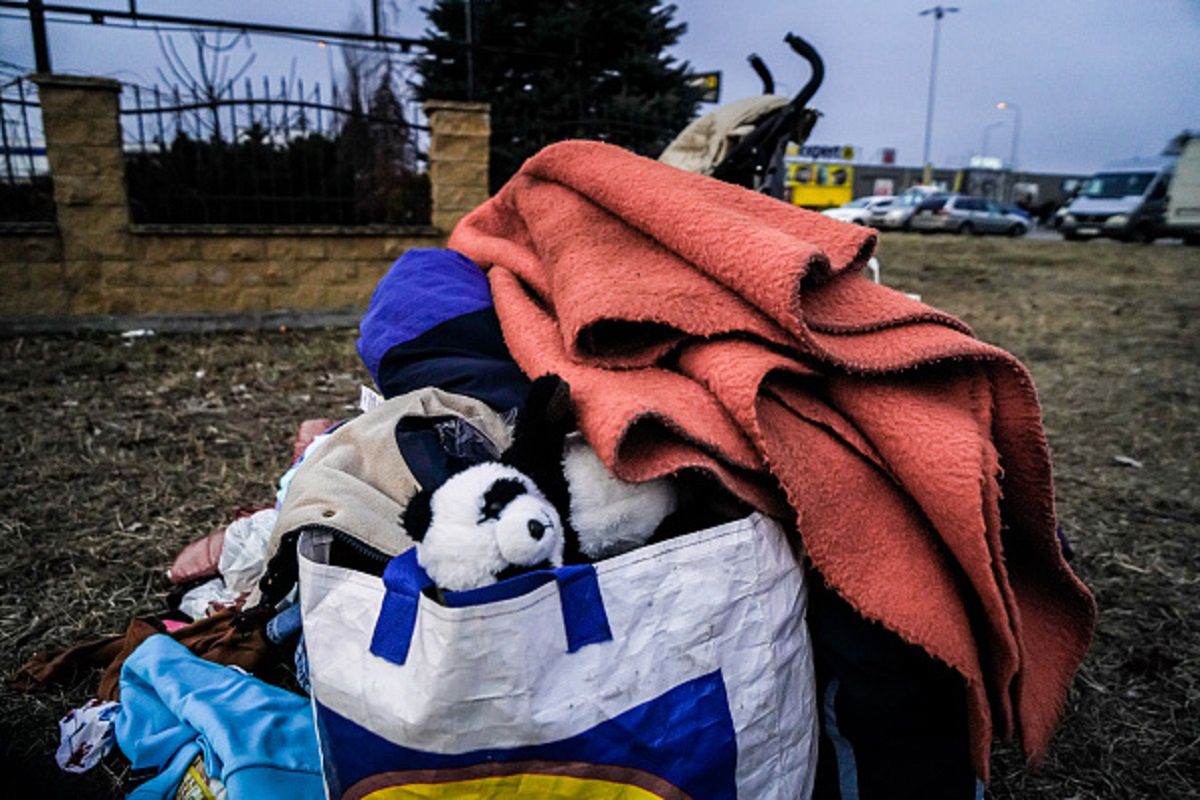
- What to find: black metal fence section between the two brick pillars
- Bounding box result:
[121,79,431,225]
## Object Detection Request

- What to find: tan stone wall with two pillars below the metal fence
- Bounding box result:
[0,76,490,327]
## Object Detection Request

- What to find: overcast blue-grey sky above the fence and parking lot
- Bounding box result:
[0,0,1200,173]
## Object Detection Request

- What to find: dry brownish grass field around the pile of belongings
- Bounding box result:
[0,234,1200,800]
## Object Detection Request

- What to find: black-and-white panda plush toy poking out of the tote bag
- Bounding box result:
[401,375,678,591]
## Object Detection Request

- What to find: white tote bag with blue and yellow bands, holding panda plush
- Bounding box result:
[300,513,817,800]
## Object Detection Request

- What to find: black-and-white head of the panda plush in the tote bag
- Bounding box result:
[402,462,564,591]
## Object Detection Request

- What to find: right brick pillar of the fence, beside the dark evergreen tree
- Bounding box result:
[425,100,492,233]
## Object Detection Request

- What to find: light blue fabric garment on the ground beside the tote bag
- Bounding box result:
[115,634,325,800]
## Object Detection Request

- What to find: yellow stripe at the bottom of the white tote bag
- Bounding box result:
[364,774,660,800]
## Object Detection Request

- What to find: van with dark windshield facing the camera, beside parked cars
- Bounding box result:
[1060,156,1176,242]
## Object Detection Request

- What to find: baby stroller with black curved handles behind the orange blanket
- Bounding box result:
[659,34,824,199]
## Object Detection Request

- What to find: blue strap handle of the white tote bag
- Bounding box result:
[371,549,612,664]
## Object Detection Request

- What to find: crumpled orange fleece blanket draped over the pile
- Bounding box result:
[450,142,1096,776]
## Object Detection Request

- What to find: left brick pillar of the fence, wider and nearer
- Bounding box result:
[34,74,130,262]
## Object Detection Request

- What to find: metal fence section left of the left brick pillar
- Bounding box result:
[0,78,54,222]
